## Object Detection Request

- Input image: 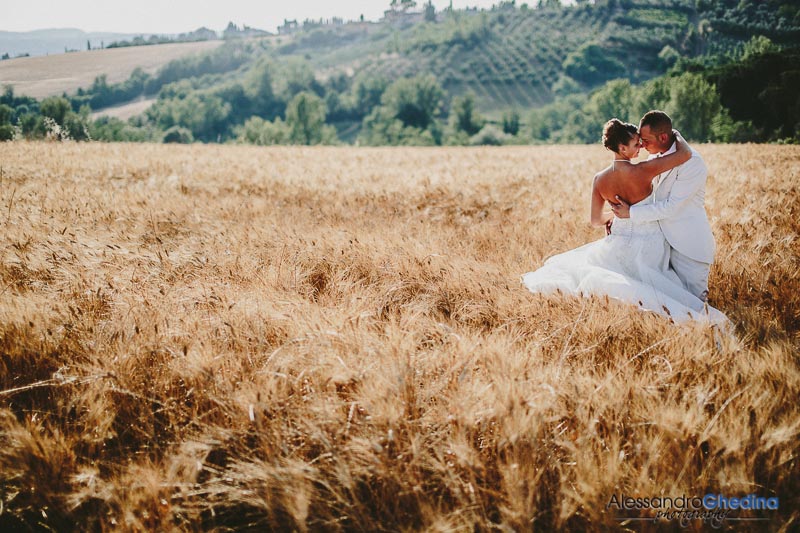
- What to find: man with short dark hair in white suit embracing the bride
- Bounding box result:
[611,111,715,301]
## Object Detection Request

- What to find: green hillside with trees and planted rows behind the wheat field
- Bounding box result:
[0,0,800,144]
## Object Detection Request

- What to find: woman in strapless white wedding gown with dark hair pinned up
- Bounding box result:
[522,119,727,323]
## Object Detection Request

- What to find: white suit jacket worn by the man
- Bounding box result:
[630,143,715,263]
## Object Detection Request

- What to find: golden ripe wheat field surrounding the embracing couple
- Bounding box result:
[0,142,800,531]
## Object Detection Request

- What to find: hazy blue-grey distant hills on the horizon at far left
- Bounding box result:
[0,28,147,57]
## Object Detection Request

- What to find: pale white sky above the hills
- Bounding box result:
[0,0,512,34]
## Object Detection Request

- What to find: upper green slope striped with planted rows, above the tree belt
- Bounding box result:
[279,0,800,111]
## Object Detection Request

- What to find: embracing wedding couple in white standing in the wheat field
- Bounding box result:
[522,111,727,324]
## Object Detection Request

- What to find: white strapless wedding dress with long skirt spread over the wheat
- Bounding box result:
[522,195,727,324]
